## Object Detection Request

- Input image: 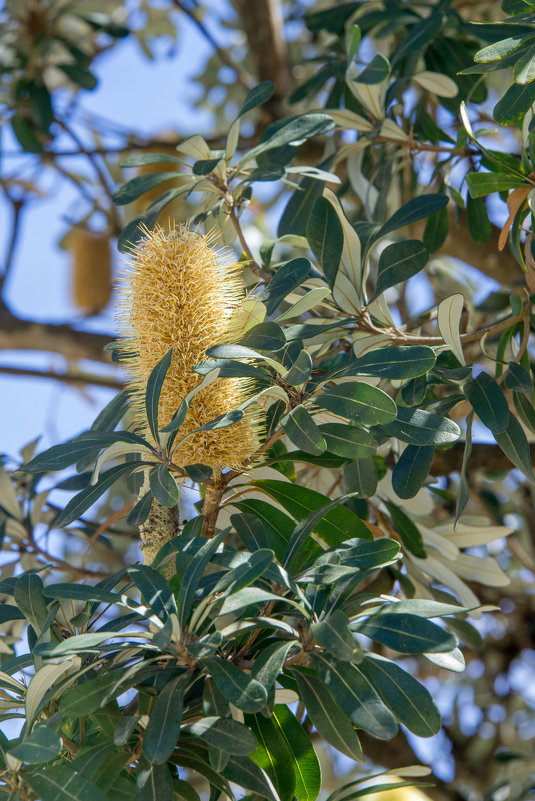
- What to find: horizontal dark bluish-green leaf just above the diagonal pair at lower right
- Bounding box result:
[353,612,456,654]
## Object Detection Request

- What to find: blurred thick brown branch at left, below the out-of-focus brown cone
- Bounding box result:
[0,307,114,363]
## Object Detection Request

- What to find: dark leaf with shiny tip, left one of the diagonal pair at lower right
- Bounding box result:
[312,655,398,740]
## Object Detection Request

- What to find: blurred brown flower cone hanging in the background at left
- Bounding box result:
[67,228,113,317]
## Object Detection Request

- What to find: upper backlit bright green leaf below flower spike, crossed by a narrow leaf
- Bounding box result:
[249,479,372,547]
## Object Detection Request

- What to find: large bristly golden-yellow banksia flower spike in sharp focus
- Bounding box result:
[119,222,258,472]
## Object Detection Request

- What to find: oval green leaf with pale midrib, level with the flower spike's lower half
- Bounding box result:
[314,381,397,425]
